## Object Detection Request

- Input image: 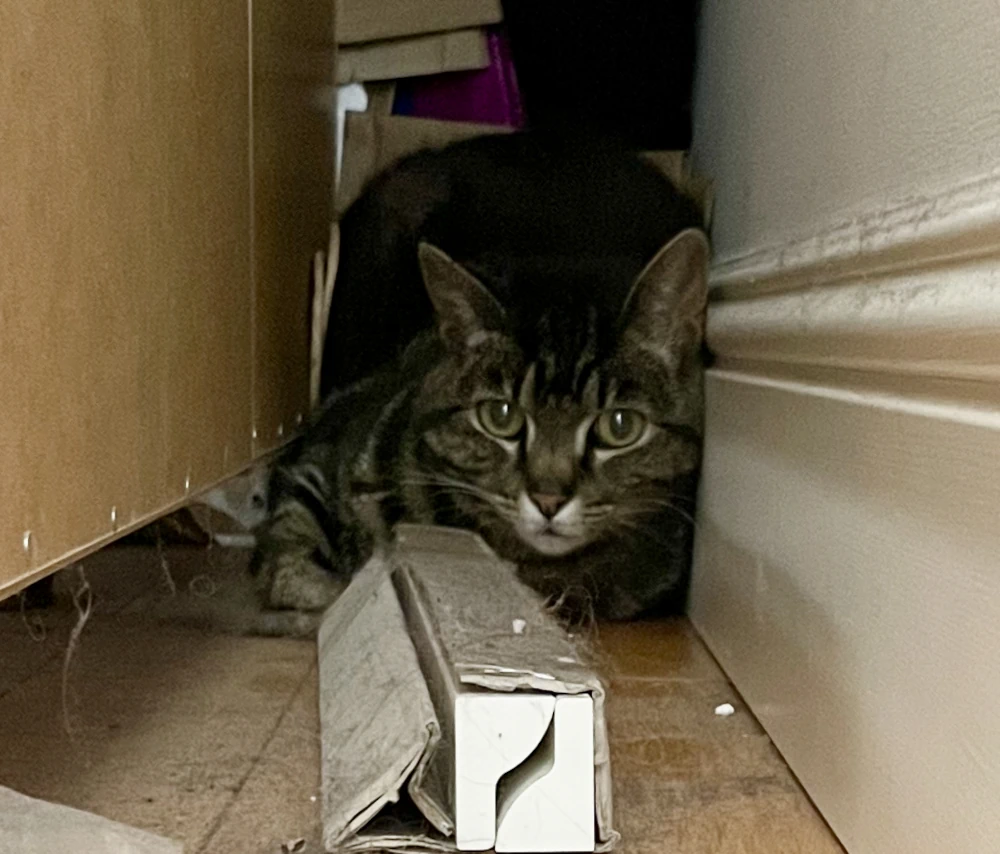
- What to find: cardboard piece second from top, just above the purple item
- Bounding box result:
[337,29,490,84]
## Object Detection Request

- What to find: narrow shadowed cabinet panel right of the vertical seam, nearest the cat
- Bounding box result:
[251,0,335,451]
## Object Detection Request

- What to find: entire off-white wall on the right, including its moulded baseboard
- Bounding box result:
[690,0,1000,854]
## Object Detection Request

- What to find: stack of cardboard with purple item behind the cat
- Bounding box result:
[337,0,709,219]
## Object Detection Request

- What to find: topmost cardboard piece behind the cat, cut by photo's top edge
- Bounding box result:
[337,0,503,45]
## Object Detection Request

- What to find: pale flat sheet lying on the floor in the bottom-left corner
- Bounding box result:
[0,786,184,854]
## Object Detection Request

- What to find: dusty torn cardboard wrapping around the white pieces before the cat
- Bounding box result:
[319,525,619,851]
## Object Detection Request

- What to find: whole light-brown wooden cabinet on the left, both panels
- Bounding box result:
[0,0,334,596]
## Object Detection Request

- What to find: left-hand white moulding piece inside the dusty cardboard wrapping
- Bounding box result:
[455,691,556,851]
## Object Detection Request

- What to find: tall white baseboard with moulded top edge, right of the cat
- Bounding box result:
[691,176,1000,854]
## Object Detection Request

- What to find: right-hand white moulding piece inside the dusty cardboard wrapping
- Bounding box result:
[496,695,595,854]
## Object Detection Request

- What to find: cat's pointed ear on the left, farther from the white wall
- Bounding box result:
[417,243,504,349]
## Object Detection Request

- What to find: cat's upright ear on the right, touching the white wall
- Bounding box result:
[622,228,709,361]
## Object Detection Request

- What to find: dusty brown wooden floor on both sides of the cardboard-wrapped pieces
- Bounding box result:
[0,548,842,854]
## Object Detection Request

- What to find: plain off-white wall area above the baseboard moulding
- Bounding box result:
[694,0,1000,260]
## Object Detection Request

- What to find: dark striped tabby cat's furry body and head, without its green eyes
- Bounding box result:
[253,137,707,618]
